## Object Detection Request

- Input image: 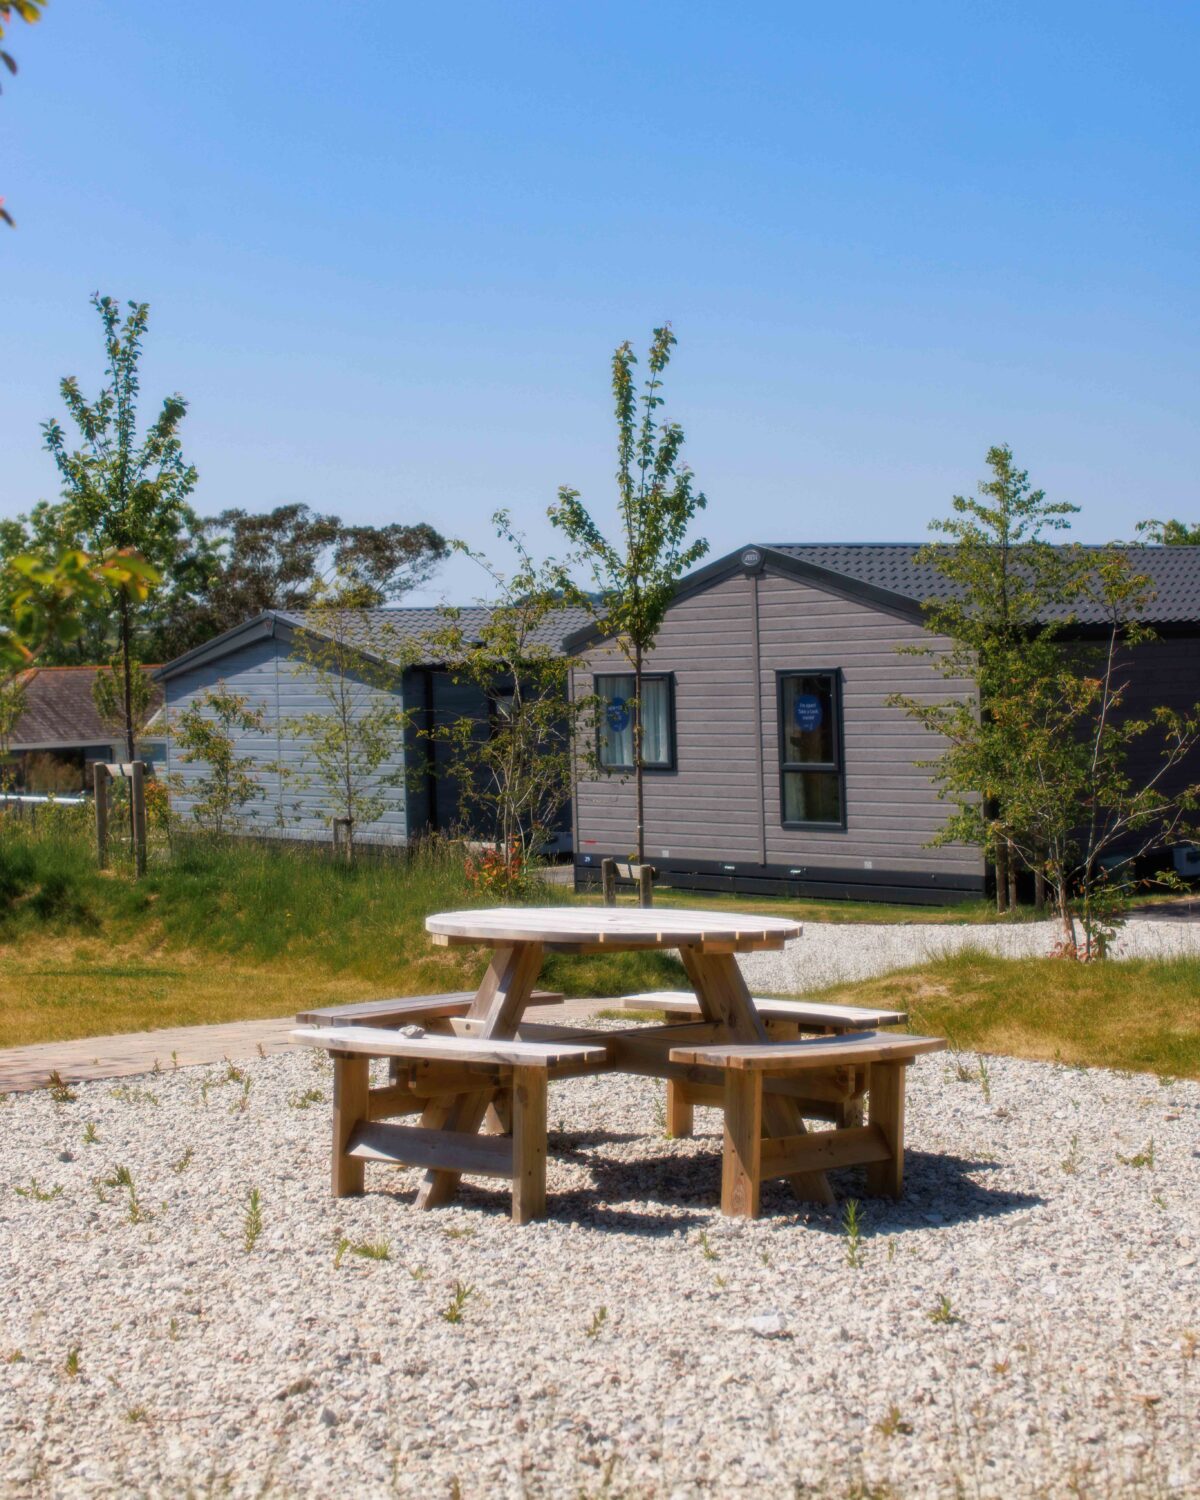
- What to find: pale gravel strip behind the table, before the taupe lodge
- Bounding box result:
[738,918,1200,995]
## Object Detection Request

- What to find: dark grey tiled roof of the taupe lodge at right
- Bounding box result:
[768,542,1200,626]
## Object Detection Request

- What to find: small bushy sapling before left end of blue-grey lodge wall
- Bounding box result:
[168,683,267,834]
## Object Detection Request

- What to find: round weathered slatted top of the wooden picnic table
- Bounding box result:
[425,906,801,950]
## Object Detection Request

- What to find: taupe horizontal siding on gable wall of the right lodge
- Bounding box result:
[576,572,983,878]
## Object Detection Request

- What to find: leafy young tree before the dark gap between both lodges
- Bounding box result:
[425,510,593,876]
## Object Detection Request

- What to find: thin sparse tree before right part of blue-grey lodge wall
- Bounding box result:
[284,579,410,861]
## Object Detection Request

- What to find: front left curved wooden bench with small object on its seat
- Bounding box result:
[291,1025,606,1224]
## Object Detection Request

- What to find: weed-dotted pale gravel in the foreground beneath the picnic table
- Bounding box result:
[0,1053,1200,1500]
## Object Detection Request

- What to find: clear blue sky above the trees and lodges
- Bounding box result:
[0,0,1200,599]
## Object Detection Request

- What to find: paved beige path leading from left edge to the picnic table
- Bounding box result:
[0,1001,605,1094]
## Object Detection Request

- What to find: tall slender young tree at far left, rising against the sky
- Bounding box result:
[42,294,197,761]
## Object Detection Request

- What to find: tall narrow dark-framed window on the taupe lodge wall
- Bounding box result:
[779,672,846,828]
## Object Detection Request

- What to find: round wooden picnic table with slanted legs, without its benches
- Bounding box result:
[417,906,833,1208]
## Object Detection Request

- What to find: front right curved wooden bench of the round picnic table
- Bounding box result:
[671,1032,947,1218]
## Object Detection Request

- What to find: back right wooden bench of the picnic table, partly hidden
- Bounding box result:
[612,990,908,1140]
